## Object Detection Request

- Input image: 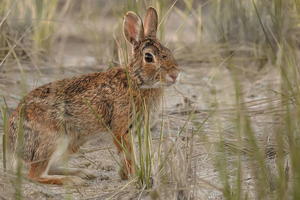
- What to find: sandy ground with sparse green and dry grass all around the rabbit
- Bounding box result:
[0,0,300,199]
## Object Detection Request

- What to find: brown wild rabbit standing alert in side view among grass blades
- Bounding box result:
[8,7,180,185]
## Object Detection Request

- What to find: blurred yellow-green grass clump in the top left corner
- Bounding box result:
[0,0,58,61]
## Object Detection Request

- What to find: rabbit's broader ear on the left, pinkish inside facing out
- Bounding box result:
[123,11,144,46]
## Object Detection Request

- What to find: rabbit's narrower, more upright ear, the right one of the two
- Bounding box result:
[144,6,158,37]
